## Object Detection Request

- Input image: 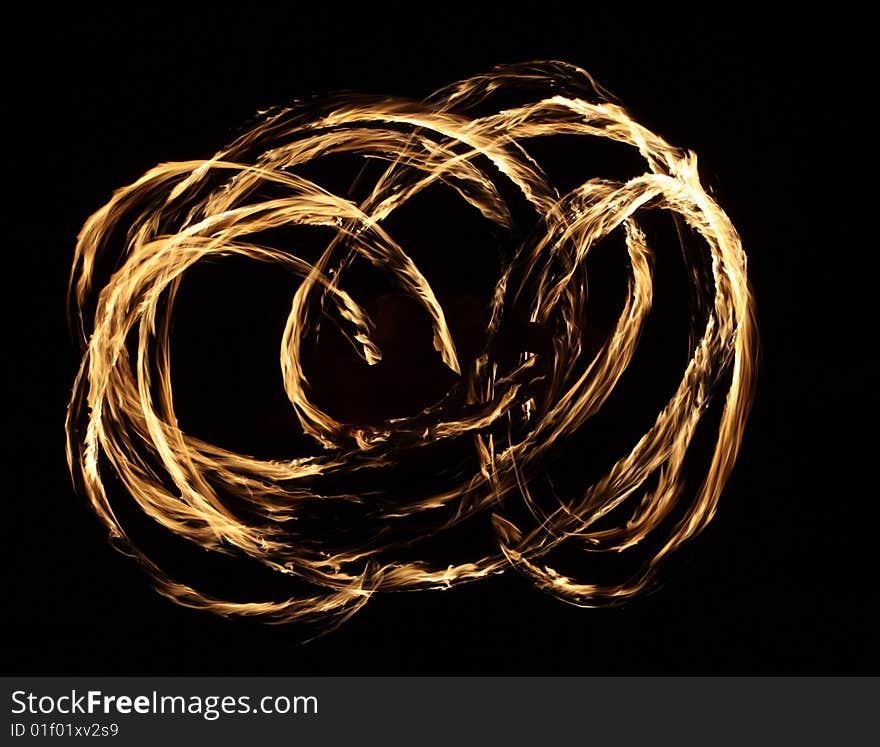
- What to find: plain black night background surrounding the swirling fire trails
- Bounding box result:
[2,3,878,675]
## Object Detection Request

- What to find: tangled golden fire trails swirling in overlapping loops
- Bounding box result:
[67,63,756,624]
